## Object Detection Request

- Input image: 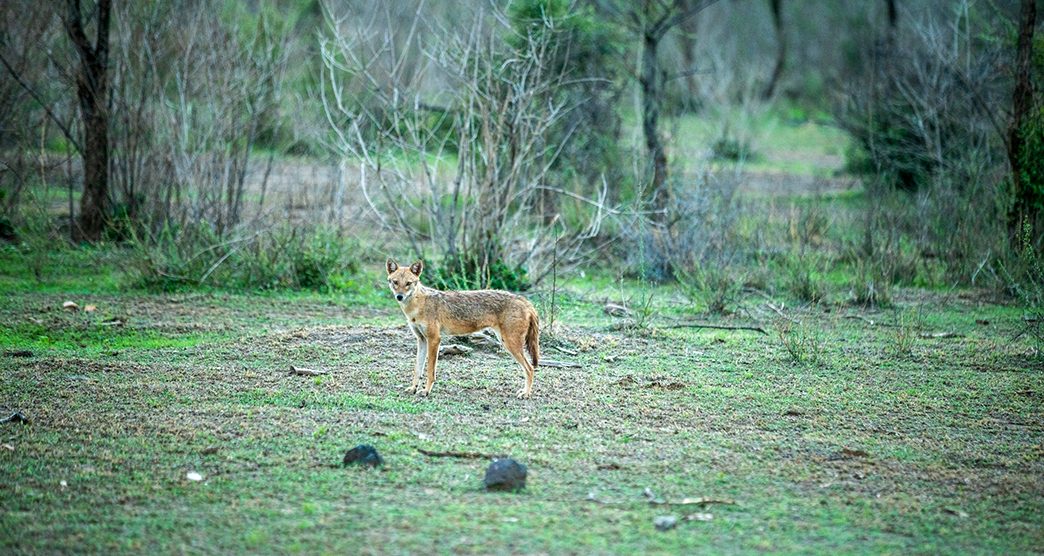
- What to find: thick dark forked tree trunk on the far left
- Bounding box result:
[65,0,112,241]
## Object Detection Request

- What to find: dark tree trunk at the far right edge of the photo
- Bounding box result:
[1007,0,1037,246]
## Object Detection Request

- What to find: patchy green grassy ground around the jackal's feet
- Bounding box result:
[0,244,1044,553]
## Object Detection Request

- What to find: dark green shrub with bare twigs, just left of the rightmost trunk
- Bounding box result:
[838,2,1010,283]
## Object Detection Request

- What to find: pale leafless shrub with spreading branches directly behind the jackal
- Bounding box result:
[321,0,606,288]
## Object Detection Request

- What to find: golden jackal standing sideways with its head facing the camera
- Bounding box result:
[387,259,540,398]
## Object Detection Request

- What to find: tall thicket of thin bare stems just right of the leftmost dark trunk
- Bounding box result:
[113,3,286,233]
